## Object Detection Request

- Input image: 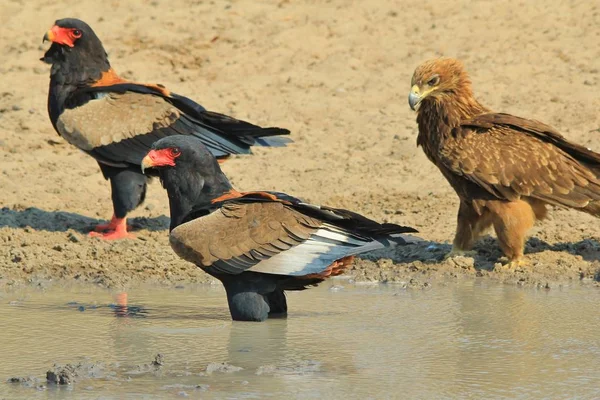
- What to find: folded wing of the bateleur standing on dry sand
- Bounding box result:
[56,83,289,166]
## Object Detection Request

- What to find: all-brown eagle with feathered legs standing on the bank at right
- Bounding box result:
[408,58,600,266]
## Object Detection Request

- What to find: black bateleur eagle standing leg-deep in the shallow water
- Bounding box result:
[142,136,416,321]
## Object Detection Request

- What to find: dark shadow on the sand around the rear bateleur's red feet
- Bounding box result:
[0,207,170,233]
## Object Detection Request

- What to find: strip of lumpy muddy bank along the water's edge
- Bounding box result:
[0,208,600,288]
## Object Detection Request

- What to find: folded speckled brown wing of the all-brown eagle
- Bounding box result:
[440,113,600,207]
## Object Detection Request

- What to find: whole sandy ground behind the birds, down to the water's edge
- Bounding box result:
[0,0,600,287]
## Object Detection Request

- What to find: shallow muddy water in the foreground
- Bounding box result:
[0,281,600,399]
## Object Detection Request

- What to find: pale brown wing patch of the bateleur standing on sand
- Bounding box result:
[56,92,181,151]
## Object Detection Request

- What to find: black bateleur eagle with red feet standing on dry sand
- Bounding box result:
[41,18,290,239]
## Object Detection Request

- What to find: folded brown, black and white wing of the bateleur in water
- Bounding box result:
[170,199,414,276]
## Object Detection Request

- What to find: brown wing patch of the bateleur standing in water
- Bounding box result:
[169,202,321,273]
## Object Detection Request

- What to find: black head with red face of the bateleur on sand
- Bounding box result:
[41,18,110,76]
